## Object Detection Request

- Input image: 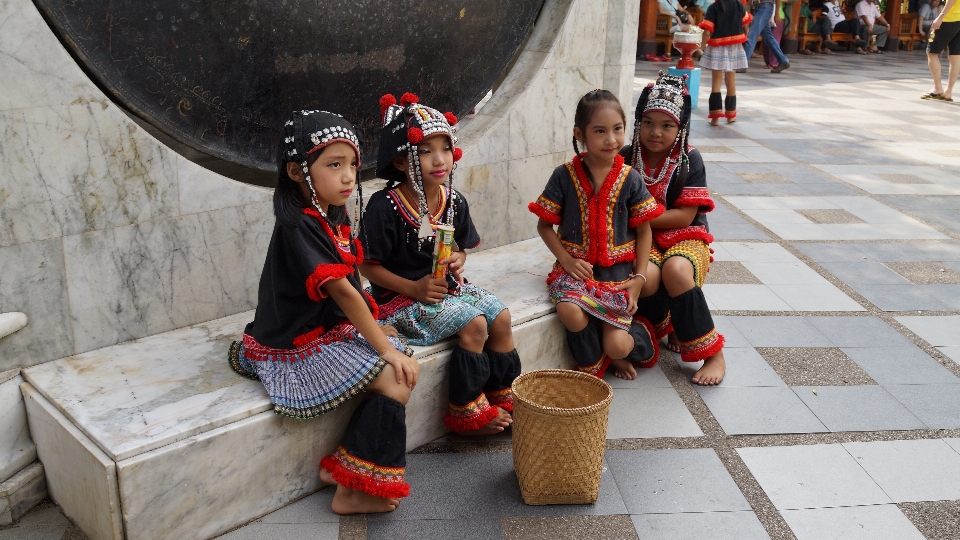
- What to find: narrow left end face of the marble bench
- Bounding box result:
[20,383,123,540]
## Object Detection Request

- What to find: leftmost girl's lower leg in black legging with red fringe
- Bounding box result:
[320,364,410,514]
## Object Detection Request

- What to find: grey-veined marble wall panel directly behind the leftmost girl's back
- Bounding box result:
[64,202,273,353]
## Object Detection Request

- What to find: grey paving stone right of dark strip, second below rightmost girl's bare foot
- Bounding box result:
[695,386,829,435]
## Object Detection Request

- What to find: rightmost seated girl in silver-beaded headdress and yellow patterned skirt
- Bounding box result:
[621,71,726,385]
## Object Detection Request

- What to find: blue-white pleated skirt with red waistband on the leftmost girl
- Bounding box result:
[229,323,413,420]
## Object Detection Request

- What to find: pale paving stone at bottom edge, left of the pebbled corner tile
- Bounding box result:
[780,504,924,540]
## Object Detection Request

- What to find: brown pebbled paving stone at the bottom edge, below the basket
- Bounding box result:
[498,515,638,540]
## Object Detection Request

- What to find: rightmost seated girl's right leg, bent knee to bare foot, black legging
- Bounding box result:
[660,240,726,385]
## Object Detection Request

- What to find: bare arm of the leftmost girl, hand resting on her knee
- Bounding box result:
[323,278,420,388]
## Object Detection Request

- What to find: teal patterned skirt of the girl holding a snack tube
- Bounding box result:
[380,283,507,346]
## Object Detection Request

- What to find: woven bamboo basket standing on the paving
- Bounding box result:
[513,369,613,505]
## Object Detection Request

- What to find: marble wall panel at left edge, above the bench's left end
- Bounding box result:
[0,238,73,370]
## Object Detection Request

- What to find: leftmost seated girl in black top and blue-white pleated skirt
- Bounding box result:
[229,111,419,514]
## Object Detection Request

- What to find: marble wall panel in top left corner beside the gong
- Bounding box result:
[0,0,106,111]
